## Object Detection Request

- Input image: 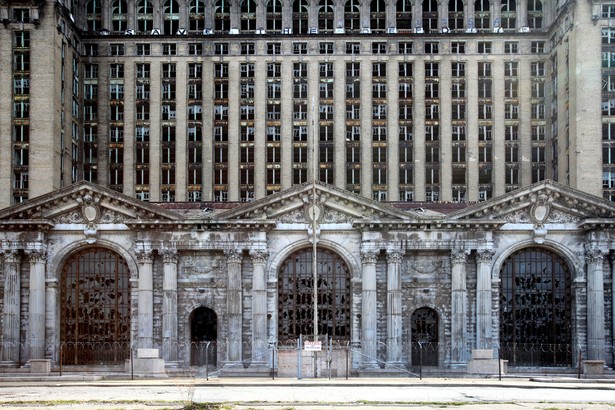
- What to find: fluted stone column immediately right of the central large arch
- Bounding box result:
[361,251,378,367]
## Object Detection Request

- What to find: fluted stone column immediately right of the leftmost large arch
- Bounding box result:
[137,250,154,349]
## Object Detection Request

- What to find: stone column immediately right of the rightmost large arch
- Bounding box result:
[585,246,605,360]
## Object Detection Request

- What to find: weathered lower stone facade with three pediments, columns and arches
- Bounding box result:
[0,181,615,375]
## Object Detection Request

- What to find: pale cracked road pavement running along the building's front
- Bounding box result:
[0,378,615,410]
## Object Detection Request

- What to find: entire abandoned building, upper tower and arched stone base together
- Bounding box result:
[0,0,615,374]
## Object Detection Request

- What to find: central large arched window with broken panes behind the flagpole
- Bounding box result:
[278,249,350,342]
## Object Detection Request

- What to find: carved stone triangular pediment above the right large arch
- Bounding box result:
[450,180,615,224]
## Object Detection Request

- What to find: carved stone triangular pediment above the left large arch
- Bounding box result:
[0,181,178,225]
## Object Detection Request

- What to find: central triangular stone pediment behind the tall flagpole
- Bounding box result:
[218,182,418,223]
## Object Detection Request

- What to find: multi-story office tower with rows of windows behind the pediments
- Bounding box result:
[0,0,615,206]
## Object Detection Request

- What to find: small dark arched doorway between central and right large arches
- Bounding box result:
[410,307,438,366]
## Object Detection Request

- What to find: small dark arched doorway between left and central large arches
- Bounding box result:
[190,306,218,366]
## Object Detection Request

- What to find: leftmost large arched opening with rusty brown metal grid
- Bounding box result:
[59,248,130,365]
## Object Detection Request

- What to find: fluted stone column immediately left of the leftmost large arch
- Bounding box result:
[26,249,47,359]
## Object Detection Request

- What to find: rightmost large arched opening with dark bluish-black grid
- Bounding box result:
[500,248,572,366]
